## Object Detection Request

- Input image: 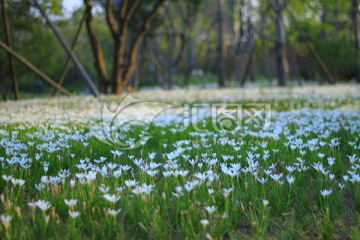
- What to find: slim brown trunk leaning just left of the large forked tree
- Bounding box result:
[84,0,109,93]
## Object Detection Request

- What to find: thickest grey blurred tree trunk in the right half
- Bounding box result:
[275,0,289,86]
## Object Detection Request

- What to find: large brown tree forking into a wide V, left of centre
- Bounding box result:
[84,0,166,94]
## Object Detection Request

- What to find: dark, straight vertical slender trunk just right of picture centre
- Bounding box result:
[217,0,225,88]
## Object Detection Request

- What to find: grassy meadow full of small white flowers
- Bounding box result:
[0,87,360,239]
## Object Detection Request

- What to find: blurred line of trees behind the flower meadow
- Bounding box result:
[0,0,360,99]
